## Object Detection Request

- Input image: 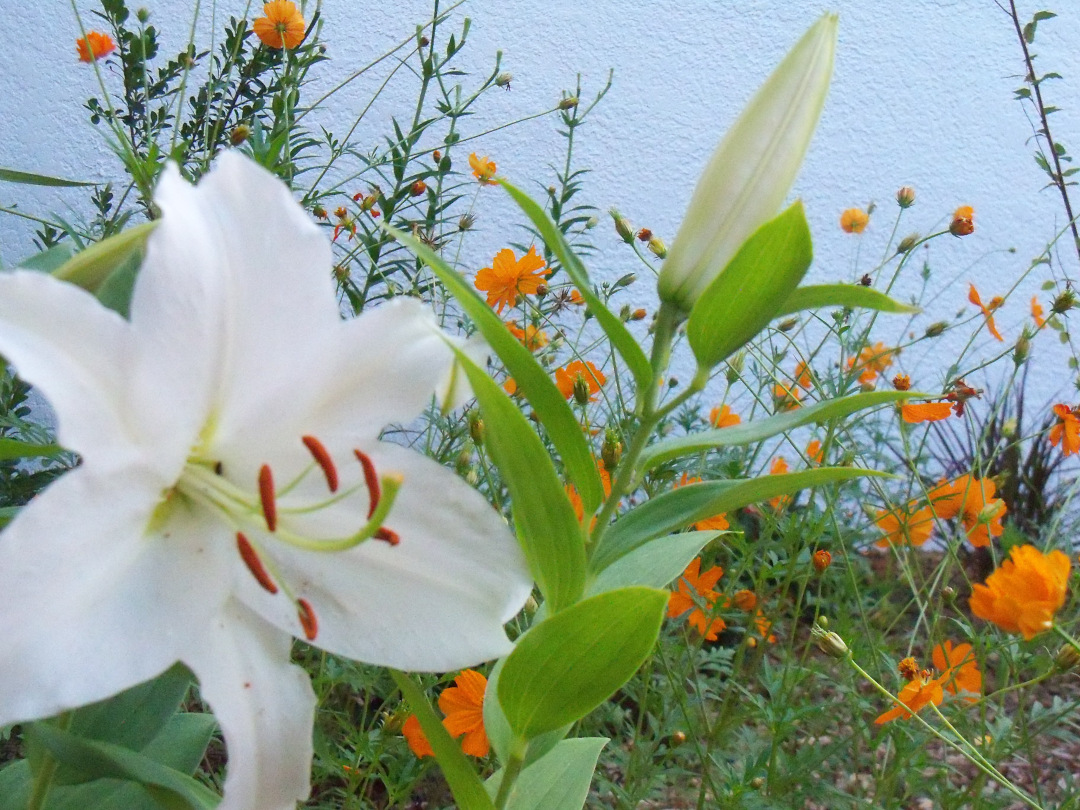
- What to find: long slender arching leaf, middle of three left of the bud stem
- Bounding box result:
[386,227,604,514]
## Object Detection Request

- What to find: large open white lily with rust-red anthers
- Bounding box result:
[0,153,530,810]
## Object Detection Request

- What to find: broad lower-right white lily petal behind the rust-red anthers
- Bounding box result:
[241,443,531,672]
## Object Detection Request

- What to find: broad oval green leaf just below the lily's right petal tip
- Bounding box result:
[499,588,667,740]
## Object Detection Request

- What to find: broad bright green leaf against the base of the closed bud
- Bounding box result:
[686,201,813,368]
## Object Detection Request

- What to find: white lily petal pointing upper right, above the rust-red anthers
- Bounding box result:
[216,298,453,482]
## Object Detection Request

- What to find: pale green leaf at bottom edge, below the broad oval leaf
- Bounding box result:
[487,737,608,810]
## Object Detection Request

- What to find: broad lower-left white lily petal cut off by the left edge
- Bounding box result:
[0,468,229,726]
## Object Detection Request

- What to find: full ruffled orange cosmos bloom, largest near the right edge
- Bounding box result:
[968,545,1071,640]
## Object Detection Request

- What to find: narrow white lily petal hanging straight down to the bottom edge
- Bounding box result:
[183,599,315,810]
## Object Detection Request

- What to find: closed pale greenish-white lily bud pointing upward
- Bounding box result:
[658,14,837,312]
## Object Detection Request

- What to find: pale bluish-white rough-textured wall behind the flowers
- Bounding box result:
[0,0,1080,402]
